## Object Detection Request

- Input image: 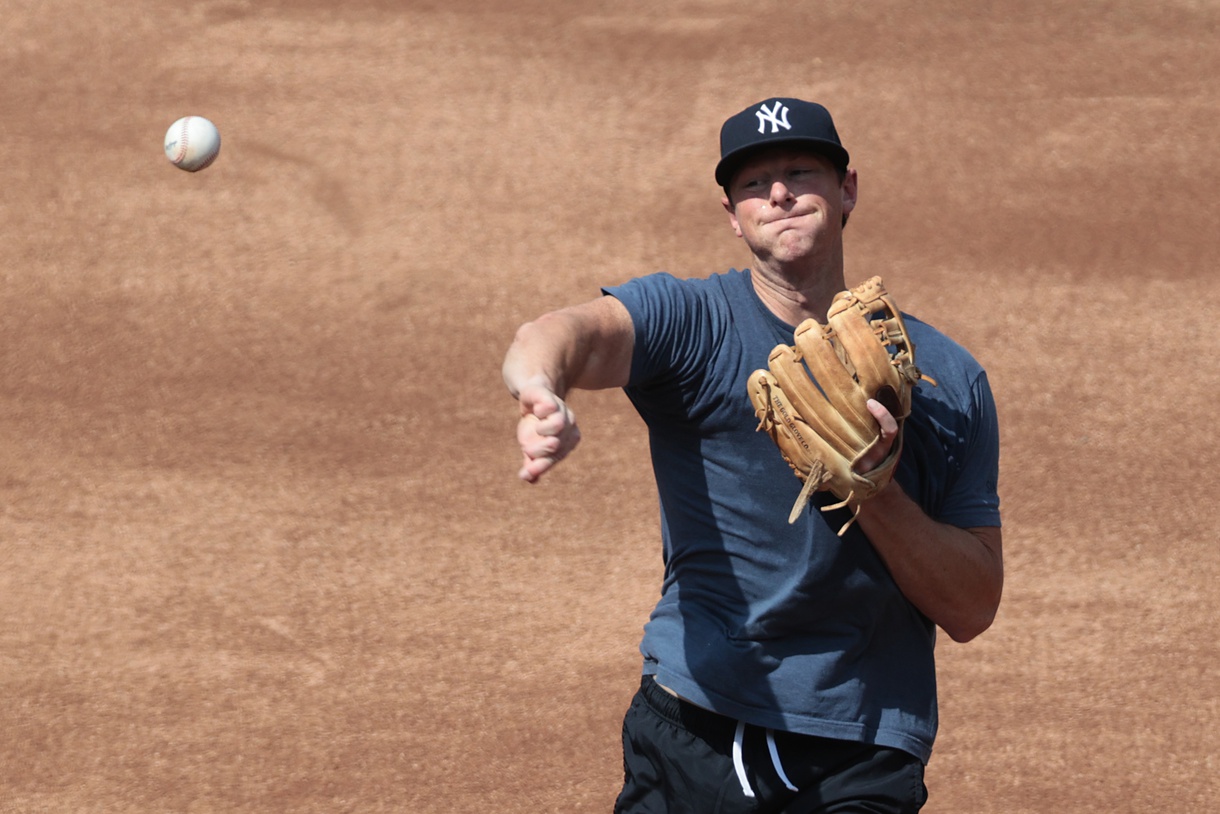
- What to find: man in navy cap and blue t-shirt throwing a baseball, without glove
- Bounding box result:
[504,99,1003,814]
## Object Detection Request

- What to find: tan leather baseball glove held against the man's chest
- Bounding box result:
[749,277,936,536]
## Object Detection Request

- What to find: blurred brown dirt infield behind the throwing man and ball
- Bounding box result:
[0,0,1220,814]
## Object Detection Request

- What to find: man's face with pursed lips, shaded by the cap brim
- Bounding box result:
[723,146,856,264]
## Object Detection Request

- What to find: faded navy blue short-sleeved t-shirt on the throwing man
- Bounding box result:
[604,270,1000,762]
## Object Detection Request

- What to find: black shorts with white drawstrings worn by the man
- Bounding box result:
[614,676,927,814]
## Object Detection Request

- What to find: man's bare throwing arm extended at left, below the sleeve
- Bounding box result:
[503,297,636,483]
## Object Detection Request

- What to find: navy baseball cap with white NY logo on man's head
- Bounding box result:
[716,99,848,187]
